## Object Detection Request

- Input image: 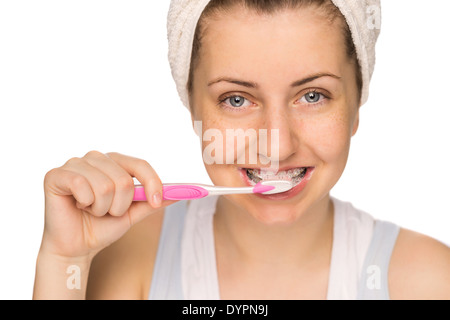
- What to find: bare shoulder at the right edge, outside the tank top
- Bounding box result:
[389,229,450,300]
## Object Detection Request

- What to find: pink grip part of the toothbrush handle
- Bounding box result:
[133,184,209,201]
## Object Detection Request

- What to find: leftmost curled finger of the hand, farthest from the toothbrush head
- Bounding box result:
[44,168,95,208]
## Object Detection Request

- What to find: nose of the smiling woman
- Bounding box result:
[261,103,299,163]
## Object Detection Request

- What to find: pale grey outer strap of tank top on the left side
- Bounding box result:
[149,201,187,300]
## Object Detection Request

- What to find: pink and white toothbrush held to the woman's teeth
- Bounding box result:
[133,180,293,201]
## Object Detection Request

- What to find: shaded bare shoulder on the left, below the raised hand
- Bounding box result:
[86,209,165,300]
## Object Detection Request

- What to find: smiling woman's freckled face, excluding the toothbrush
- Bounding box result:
[191,7,359,225]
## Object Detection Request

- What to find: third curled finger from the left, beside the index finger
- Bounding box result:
[84,151,134,216]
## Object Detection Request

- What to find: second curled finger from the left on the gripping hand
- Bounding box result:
[64,158,115,217]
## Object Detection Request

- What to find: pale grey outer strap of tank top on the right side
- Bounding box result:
[357,220,400,300]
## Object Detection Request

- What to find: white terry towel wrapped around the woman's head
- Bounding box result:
[167,0,381,109]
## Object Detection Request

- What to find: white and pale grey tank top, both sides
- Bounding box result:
[149,196,399,300]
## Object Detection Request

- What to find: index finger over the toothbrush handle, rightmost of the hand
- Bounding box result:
[106,152,162,208]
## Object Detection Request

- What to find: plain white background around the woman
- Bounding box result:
[0,0,450,299]
